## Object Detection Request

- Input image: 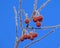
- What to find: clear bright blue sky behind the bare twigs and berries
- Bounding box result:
[0,0,60,48]
